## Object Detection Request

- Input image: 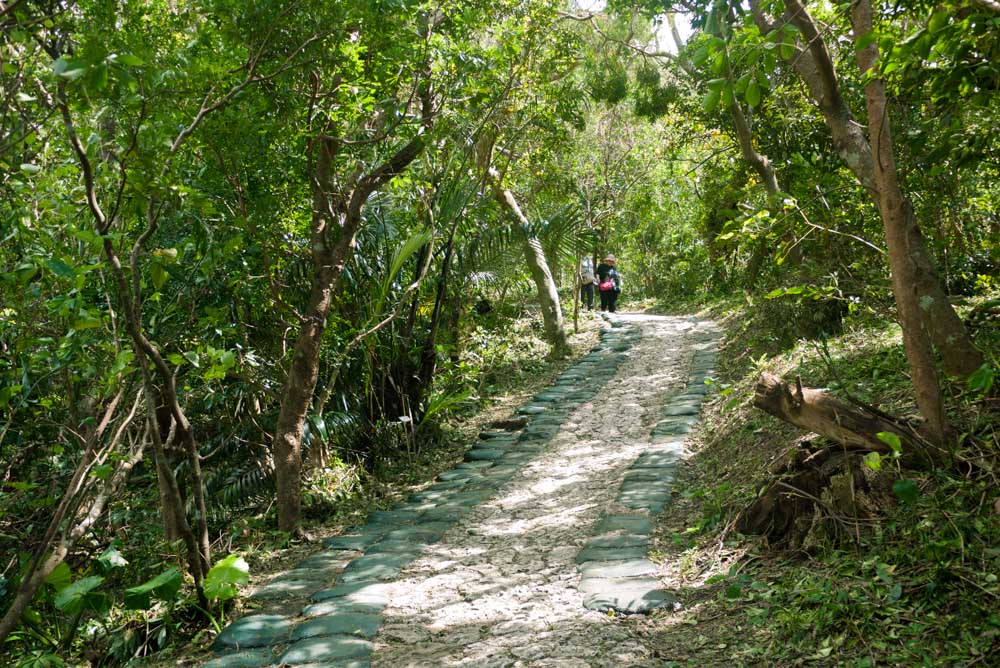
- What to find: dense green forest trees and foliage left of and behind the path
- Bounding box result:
[0,0,1000,665]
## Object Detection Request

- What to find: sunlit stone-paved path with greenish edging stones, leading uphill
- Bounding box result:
[206,314,718,668]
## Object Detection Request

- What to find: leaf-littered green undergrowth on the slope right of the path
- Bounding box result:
[657,294,1000,666]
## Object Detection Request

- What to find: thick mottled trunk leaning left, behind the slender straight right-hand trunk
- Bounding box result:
[764,0,983,377]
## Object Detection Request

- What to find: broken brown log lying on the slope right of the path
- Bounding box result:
[753,372,926,456]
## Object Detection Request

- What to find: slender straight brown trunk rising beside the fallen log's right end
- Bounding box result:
[851,0,953,445]
